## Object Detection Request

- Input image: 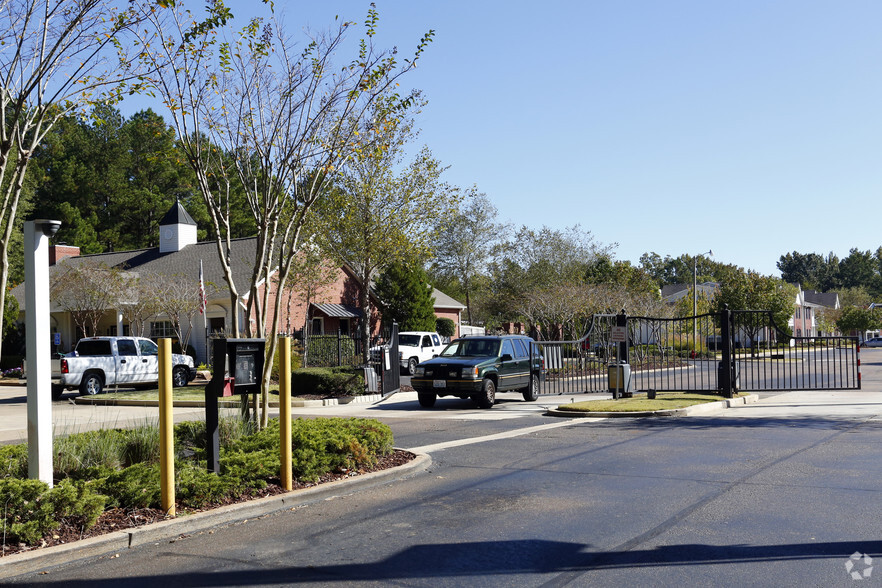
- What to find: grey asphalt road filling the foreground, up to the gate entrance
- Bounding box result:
[7,350,882,587]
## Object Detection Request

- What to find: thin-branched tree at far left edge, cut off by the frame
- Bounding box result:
[0,0,151,358]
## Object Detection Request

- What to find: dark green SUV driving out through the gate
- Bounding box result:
[410,335,545,408]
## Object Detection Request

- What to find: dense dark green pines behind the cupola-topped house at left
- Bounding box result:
[34,105,219,253]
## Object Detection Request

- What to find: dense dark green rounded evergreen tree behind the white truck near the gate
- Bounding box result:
[376,262,435,331]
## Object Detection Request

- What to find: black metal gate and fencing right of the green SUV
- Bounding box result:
[541,310,861,396]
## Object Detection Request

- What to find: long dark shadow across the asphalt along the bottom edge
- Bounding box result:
[10,540,882,588]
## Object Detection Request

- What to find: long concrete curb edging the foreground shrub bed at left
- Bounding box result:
[0,450,432,578]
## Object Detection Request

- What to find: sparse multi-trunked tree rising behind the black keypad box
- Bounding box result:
[134,0,432,425]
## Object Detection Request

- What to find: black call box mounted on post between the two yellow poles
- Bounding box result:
[208,339,266,397]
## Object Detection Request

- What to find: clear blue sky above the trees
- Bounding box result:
[118,0,882,275]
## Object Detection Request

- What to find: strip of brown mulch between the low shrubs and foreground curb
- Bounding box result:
[2,450,416,555]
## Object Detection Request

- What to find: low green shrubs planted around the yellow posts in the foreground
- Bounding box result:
[0,418,414,555]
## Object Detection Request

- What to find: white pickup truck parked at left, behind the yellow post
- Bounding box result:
[52,337,196,400]
